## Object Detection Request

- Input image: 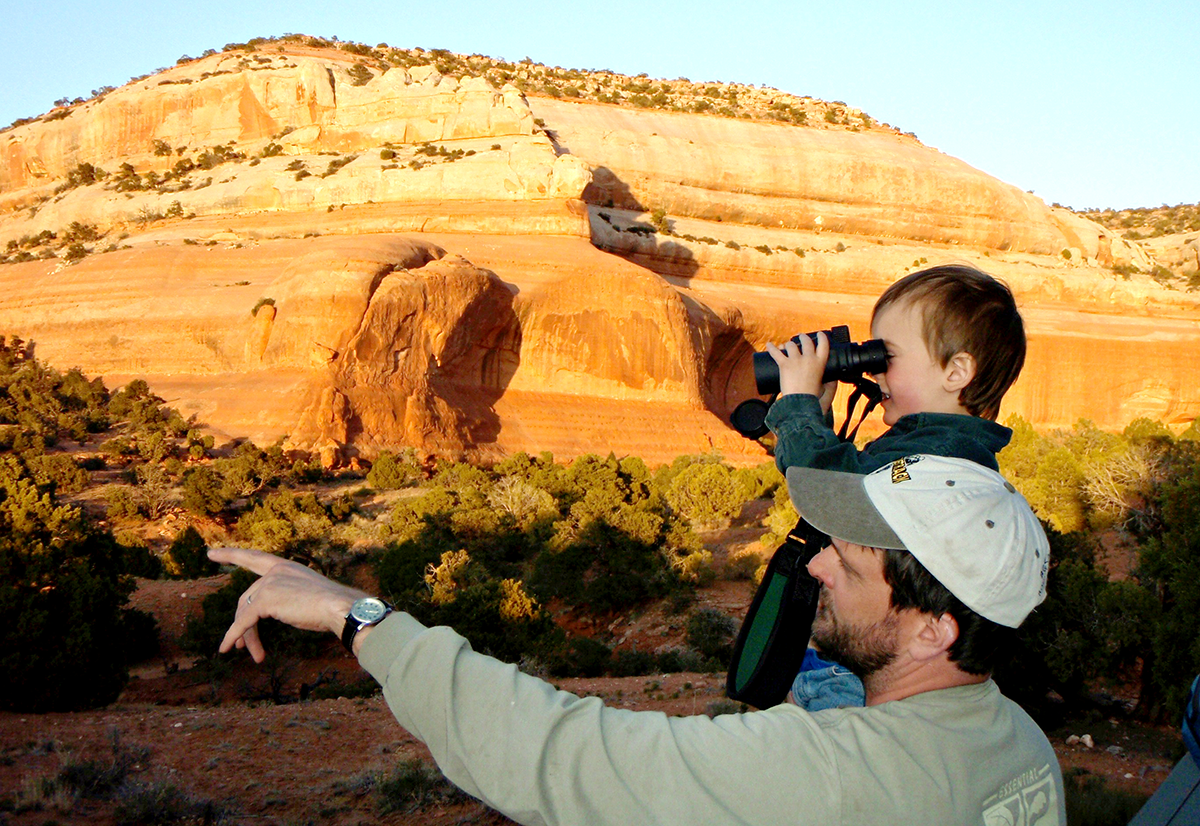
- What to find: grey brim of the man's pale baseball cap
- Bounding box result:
[787,467,908,551]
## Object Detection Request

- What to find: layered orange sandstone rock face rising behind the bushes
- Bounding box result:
[0,44,1200,463]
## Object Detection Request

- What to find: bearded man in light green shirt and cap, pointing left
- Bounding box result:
[210,456,1066,826]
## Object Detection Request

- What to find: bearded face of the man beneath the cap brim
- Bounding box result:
[809,539,899,678]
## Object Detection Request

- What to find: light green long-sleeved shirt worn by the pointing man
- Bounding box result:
[360,612,1067,826]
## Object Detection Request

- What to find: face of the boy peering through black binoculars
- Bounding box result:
[871,296,966,426]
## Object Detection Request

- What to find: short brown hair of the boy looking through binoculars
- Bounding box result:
[871,264,1025,421]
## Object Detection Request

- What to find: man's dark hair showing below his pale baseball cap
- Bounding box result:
[883,550,1015,675]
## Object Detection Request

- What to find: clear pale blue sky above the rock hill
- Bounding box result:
[0,0,1200,208]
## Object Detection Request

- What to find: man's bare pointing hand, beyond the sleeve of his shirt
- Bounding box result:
[209,547,370,663]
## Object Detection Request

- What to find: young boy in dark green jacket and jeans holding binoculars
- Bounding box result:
[767,265,1025,711]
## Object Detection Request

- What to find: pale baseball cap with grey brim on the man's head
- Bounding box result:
[787,455,1050,628]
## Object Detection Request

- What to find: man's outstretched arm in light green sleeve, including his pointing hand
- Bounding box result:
[209,549,841,826]
